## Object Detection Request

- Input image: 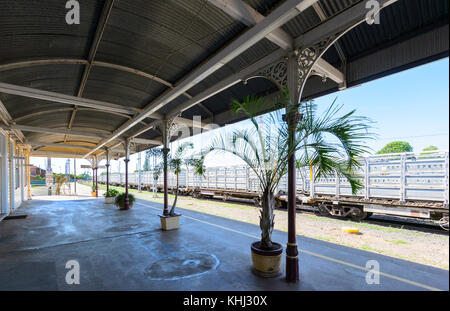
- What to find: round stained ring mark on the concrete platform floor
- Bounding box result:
[144,253,219,280]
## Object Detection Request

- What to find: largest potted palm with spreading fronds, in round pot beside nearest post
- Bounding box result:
[208,92,369,277]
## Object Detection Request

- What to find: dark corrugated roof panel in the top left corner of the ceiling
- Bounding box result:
[0,0,102,63]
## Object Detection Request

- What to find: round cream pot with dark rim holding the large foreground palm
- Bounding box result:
[251,242,283,278]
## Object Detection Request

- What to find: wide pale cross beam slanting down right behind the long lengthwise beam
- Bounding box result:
[208,0,344,84]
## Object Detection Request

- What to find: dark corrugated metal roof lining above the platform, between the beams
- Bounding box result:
[0,0,449,158]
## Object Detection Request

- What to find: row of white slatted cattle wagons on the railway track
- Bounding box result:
[99,152,449,228]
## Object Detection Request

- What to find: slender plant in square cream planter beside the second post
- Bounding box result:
[159,142,194,230]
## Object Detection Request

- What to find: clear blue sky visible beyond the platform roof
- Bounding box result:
[31,58,449,172]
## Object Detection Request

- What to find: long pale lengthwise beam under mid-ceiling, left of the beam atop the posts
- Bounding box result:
[81,0,317,160]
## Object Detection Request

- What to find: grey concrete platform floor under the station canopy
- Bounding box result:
[0,198,449,291]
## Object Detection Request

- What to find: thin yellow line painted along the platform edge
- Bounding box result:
[137,203,443,291]
